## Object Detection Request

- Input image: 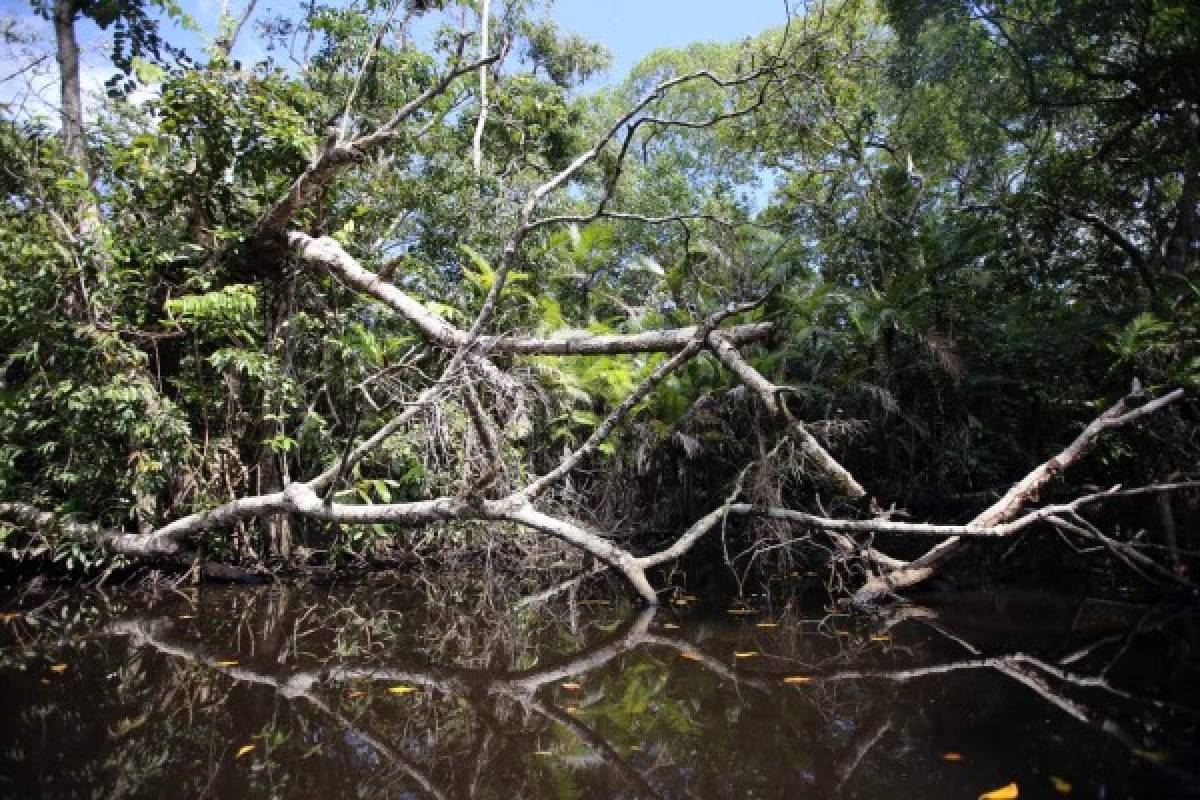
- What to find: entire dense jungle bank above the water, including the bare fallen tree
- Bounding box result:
[0,0,1200,600]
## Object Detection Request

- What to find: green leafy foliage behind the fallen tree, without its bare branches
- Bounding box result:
[0,0,1200,573]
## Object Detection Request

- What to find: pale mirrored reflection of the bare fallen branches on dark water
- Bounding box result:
[109,607,1195,798]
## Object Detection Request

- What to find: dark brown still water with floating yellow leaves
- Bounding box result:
[0,585,1200,799]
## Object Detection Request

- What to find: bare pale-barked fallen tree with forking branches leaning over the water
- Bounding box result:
[0,0,1196,604]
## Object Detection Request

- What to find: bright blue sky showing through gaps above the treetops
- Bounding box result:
[0,0,796,110]
